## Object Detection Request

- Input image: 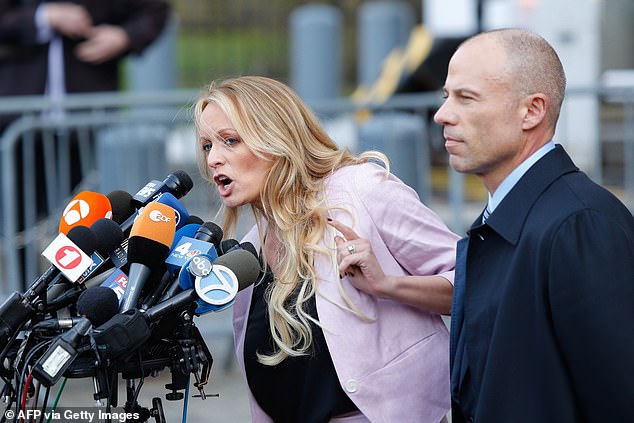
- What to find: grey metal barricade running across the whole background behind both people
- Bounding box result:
[0,87,634,296]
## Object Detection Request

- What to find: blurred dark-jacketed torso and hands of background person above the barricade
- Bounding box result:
[0,0,169,109]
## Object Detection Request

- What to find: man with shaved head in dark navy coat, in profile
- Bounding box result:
[435,29,634,423]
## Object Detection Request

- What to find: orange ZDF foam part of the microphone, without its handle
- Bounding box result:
[130,201,176,249]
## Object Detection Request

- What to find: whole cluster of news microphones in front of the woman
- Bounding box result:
[0,171,261,421]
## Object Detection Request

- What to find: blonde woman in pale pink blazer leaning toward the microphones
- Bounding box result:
[195,77,458,423]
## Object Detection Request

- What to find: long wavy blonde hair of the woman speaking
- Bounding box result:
[194,76,389,365]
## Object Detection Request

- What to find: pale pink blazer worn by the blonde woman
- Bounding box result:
[233,163,459,423]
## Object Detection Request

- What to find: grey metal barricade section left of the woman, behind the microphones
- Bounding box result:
[0,91,195,293]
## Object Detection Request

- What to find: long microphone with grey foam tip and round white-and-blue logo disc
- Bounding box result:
[93,250,260,359]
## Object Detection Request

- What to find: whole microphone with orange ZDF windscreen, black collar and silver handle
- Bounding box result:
[120,202,176,312]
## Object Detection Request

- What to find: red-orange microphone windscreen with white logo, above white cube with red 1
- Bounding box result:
[59,191,112,235]
